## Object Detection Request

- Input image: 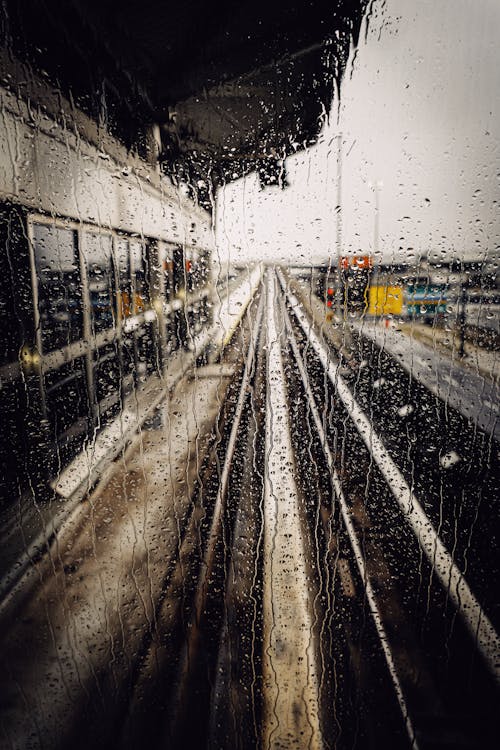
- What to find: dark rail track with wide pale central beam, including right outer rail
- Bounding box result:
[153,271,499,748]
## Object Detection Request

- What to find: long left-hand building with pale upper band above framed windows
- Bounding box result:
[0,79,213,502]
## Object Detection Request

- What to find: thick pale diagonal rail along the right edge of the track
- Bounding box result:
[278,272,500,682]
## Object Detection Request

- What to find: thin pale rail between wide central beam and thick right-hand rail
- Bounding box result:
[283,296,418,750]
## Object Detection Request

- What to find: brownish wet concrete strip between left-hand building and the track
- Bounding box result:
[0,284,266,749]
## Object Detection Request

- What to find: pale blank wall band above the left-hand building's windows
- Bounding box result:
[0,88,213,249]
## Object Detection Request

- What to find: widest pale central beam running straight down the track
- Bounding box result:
[262,271,322,750]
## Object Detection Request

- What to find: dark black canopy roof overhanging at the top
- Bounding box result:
[3,0,368,206]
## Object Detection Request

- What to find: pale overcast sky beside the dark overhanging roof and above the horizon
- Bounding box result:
[216,0,500,263]
